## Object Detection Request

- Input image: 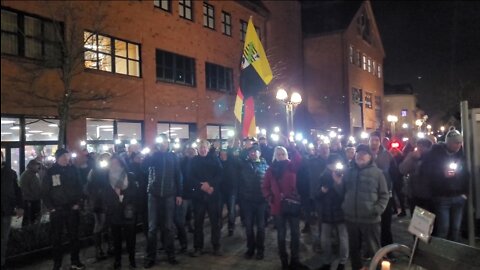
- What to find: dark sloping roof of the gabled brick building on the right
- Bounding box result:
[302,0,363,35]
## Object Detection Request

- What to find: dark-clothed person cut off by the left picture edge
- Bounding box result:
[1,151,23,269]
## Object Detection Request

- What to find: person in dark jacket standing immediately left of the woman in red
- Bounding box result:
[239,145,268,260]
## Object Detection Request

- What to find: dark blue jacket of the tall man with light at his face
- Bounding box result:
[144,152,183,197]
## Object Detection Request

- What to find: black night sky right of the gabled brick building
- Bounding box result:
[372,1,480,122]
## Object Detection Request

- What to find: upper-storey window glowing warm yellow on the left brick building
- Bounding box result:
[84,31,140,77]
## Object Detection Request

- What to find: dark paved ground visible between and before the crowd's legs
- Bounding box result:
[12,214,412,270]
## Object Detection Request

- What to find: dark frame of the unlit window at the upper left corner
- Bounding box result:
[0,6,64,61]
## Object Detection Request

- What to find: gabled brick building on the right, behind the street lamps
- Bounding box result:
[302,1,385,135]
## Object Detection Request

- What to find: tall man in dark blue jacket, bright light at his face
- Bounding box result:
[144,136,182,268]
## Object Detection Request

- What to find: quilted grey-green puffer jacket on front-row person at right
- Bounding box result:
[336,163,389,224]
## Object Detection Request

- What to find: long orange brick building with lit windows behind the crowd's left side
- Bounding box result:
[1,0,303,170]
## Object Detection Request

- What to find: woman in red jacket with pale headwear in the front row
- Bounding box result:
[262,146,308,270]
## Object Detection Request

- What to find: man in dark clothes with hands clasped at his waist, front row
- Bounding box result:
[189,140,222,257]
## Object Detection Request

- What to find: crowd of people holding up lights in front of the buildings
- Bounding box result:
[1,130,468,270]
